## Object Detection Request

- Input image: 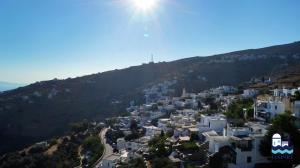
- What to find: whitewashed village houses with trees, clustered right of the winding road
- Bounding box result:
[98,79,300,168]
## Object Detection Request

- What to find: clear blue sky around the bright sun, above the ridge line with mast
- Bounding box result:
[0,0,300,83]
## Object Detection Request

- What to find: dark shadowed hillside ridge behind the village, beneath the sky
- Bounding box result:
[0,42,300,153]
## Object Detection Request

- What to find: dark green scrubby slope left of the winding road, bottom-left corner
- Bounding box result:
[0,121,103,168]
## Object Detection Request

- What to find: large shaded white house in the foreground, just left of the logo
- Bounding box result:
[207,123,268,168]
